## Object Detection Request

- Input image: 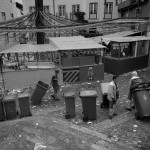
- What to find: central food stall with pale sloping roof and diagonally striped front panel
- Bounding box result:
[49,36,106,82]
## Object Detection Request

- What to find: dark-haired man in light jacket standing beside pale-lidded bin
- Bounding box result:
[107,76,119,119]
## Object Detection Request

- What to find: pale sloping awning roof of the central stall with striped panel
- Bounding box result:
[49,36,106,50]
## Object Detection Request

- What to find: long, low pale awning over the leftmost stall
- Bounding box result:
[0,44,58,54]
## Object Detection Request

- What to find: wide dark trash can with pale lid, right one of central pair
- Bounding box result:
[79,90,97,121]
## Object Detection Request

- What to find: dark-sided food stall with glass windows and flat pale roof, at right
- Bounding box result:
[99,36,150,75]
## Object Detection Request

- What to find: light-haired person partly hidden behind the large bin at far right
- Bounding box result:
[125,71,139,111]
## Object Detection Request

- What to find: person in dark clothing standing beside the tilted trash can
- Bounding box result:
[50,70,59,100]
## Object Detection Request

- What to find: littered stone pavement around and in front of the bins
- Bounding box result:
[0,68,150,150]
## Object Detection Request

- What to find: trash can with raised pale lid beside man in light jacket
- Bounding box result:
[100,83,109,108]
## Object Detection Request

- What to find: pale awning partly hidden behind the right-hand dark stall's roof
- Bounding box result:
[89,31,142,44]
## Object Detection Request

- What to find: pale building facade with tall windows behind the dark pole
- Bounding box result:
[23,0,119,22]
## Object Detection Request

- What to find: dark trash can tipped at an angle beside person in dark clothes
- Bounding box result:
[30,81,49,105]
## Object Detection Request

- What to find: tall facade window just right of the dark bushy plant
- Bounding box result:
[89,3,98,19]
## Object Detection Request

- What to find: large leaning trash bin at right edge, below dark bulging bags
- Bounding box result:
[132,89,150,119]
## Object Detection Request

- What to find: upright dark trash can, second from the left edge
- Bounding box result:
[3,95,17,120]
